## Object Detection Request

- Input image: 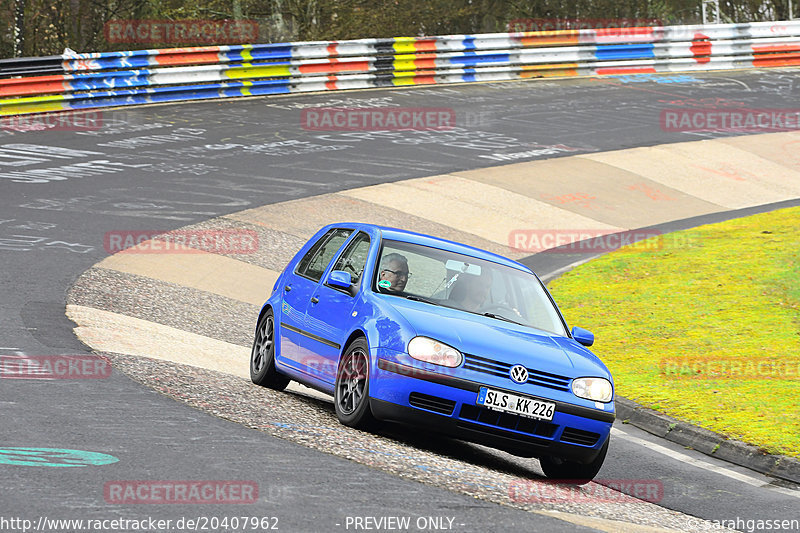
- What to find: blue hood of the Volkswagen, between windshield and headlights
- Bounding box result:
[386,296,611,379]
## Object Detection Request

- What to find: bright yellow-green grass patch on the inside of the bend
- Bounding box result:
[550,208,800,457]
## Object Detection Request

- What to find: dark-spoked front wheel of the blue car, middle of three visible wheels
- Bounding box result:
[333,337,375,429]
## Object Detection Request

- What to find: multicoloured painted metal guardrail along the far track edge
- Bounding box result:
[0,21,800,115]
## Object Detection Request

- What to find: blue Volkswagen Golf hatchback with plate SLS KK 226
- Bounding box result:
[250,224,615,483]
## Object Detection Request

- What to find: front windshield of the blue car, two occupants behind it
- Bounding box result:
[372,240,567,337]
